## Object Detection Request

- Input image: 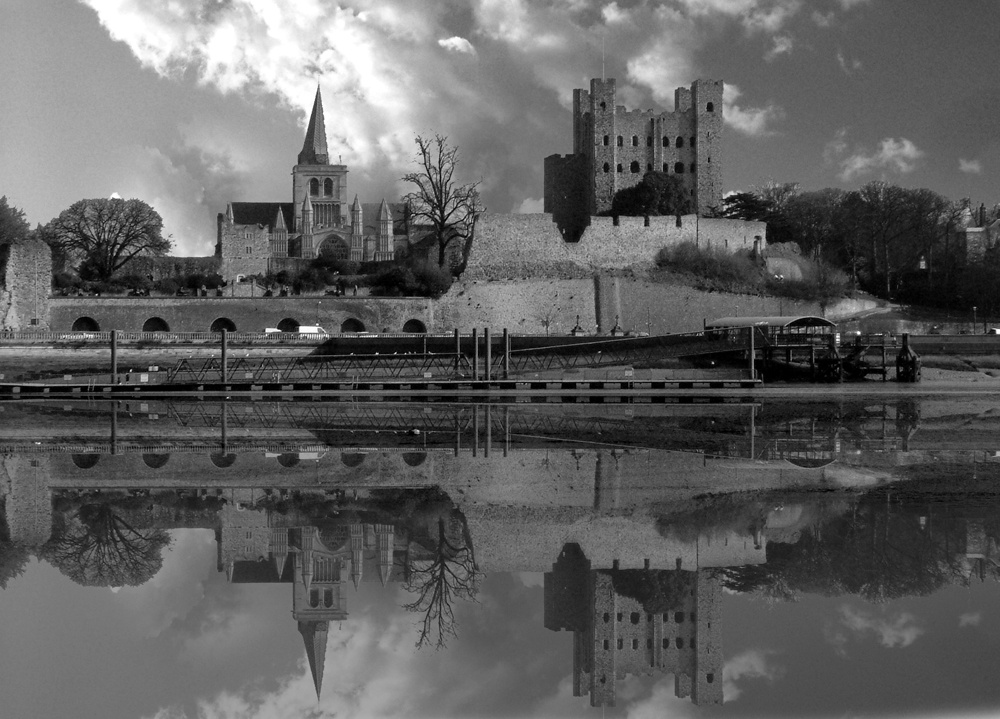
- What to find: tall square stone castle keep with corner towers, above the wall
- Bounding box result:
[545,78,723,234]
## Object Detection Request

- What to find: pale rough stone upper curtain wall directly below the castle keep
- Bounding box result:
[465,213,767,279]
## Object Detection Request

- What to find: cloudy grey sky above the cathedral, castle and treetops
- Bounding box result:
[0,0,1000,255]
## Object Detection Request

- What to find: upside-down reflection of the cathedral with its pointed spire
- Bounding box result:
[219,503,396,698]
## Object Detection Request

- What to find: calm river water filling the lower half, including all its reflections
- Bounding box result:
[0,395,1000,719]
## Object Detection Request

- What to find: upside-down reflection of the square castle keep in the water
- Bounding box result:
[545,545,722,707]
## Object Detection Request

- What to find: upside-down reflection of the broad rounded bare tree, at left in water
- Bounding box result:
[40,504,170,587]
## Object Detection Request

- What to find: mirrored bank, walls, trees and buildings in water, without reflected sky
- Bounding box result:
[0,399,1000,707]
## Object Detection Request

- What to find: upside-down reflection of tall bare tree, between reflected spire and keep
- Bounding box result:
[403,514,482,649]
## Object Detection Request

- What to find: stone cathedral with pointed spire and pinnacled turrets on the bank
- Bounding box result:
[215,87,409,282]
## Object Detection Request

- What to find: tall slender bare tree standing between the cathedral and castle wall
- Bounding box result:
[403,135,483,267]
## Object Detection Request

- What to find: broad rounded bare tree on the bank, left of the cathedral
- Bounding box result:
[44,197,171,282]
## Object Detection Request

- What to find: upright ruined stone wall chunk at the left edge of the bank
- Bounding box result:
[0,240,52,330]
